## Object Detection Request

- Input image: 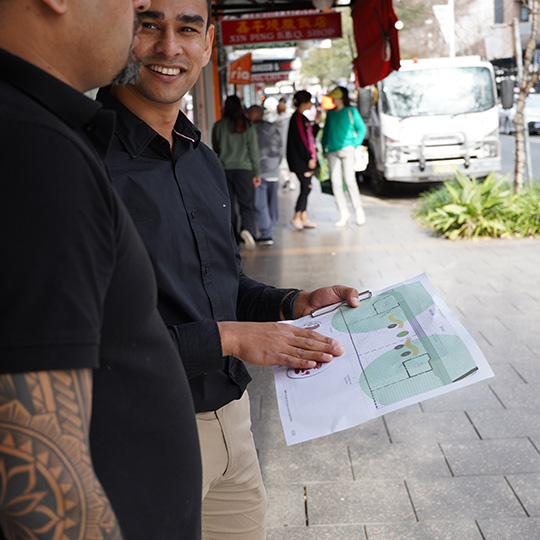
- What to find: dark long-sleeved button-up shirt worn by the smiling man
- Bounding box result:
[98,89,290,412]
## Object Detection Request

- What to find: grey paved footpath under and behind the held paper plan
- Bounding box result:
[243,180,540,540]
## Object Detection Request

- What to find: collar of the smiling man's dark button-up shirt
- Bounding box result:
[97,87,201,158]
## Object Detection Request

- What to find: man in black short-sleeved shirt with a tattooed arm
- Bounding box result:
[0,0,201,540]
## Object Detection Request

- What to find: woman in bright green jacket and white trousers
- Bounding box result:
[321,86,366,227]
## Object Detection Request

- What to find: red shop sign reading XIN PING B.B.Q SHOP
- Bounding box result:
[221,13,341,45]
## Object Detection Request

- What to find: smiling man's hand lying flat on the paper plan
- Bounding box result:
[217,321,343,369]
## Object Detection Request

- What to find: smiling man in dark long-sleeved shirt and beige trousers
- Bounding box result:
[98,0,358,540]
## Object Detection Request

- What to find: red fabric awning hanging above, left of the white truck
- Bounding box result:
[352,0,399,87]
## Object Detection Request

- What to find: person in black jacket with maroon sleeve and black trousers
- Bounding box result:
[287,90,319,231]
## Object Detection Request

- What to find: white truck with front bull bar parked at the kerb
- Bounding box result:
[360,57,501,194]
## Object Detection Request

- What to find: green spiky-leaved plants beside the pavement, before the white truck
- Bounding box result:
[416,172,540,240]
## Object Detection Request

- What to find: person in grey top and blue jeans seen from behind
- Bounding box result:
[248,105,283,246]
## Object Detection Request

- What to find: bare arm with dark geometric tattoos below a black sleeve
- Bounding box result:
[0,370,122,540]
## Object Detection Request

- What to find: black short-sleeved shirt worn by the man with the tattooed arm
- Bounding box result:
[0,50,201,540]
